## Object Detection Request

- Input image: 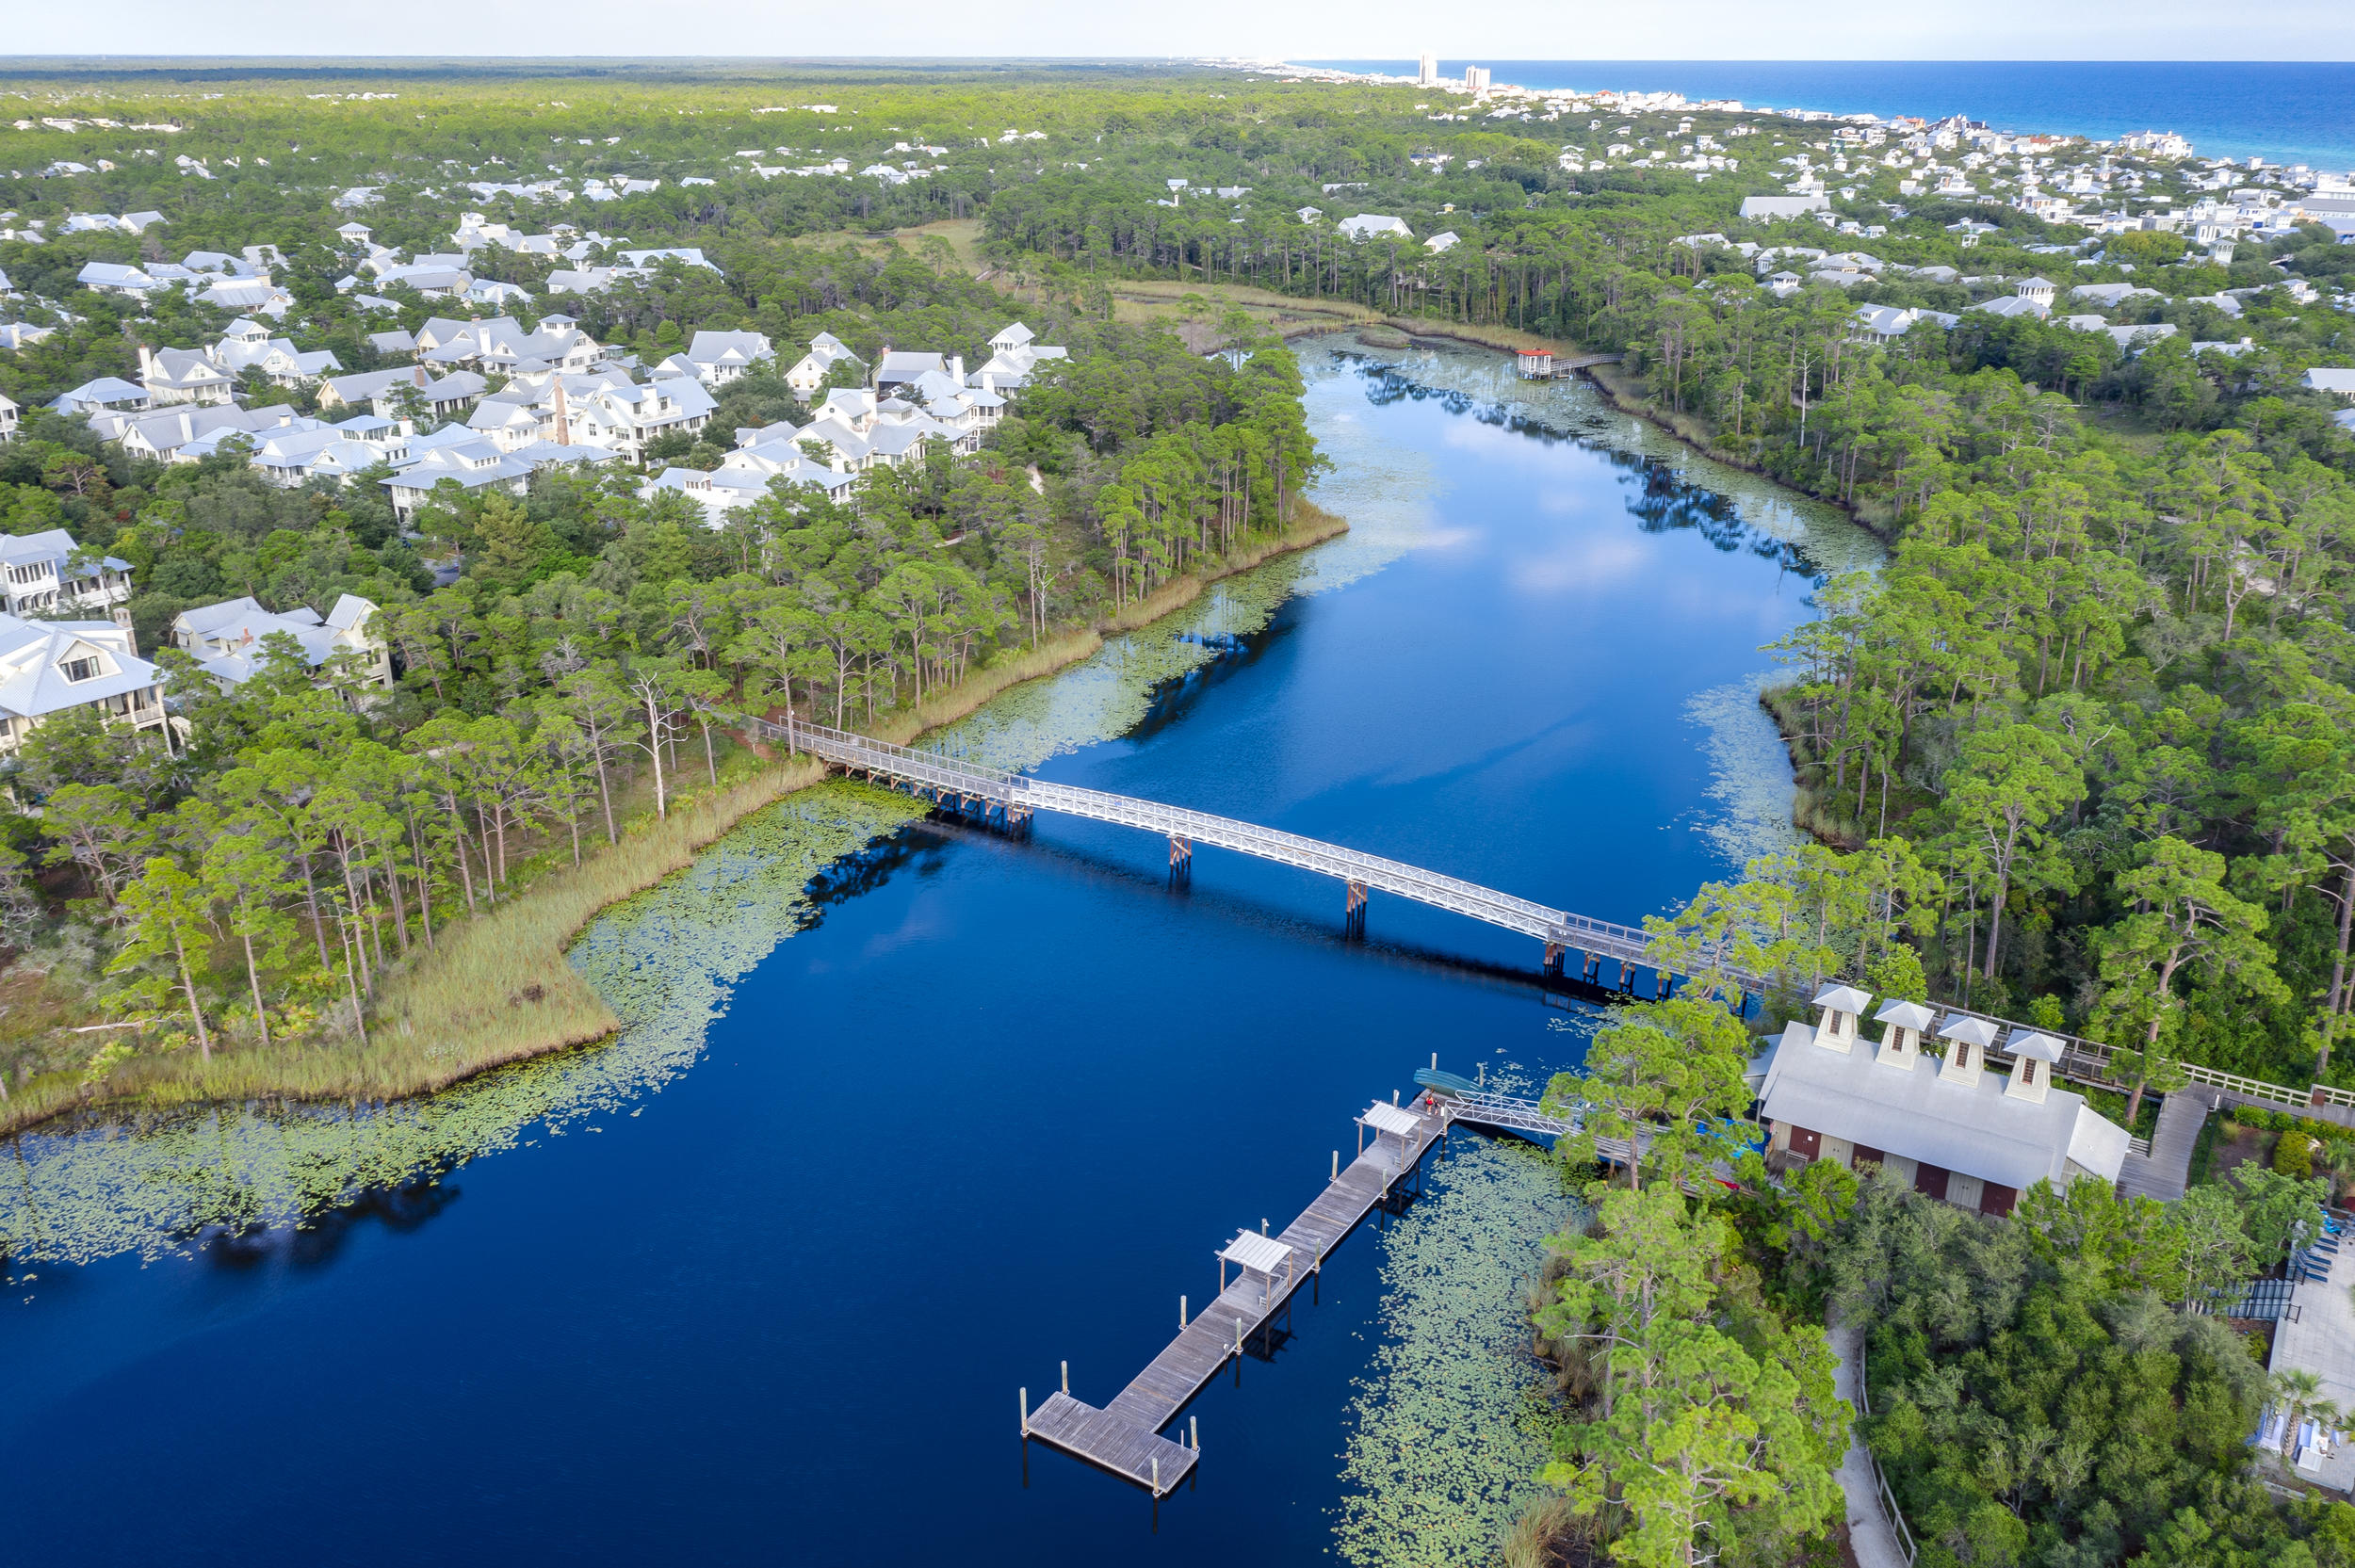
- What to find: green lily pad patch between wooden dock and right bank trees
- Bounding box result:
[1333,1138,1576,1568]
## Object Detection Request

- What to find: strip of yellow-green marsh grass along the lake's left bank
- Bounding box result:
[0,497,1350,1135]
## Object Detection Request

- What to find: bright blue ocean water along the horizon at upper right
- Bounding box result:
[1303,59,2355,170]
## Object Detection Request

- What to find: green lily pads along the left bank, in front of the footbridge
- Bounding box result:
[0,784,923,1262]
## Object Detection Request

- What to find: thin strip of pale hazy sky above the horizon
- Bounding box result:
[13,0,2355,61]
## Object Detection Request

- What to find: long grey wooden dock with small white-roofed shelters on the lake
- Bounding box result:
[1022,1100,1449,1497]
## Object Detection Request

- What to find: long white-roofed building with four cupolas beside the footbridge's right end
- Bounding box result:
[1760,987,2127,1215]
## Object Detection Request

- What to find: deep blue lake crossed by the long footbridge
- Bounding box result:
[0,342,1875,1566]
